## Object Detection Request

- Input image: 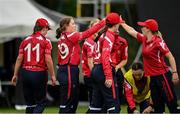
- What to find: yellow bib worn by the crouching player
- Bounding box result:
[125,69,151,103]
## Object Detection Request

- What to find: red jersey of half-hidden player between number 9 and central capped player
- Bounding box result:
[82,36,95,77]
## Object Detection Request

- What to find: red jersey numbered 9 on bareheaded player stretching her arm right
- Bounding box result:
[58,20,105,65]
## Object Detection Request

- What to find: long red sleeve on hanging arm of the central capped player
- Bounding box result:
[102,36,113,79]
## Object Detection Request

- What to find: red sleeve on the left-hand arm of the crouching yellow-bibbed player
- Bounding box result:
[123,80,136,111]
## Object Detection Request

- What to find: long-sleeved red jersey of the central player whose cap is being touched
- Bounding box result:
[94,31,115,79]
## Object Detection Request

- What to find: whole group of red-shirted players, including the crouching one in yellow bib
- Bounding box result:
[12,13,180,114]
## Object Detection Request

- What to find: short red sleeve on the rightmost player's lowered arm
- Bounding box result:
[158,39,169,55]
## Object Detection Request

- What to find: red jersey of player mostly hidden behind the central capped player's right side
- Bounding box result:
[111,35,128,66]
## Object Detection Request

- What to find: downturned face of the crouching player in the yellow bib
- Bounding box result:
[132,69,144,80]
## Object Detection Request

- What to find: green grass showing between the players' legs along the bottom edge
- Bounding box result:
[0,105,172,114]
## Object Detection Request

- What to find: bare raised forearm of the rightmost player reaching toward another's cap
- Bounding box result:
[121,23,138,38]
